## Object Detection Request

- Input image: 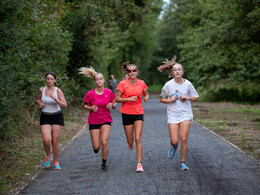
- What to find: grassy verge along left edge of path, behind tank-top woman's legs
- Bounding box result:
[0,106,88,194]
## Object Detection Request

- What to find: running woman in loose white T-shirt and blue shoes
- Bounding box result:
[158,57,199,170]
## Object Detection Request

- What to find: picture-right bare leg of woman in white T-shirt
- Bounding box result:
[180,120,190,162]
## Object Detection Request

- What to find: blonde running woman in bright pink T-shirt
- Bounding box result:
[80,67,116,171]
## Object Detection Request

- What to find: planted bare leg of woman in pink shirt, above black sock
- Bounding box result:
[100,125,111,160]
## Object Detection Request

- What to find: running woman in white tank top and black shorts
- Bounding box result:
[36,72,67,170]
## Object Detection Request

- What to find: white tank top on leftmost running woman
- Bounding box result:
[41,87,61,114]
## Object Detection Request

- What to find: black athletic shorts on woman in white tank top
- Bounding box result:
[40,112,65,126]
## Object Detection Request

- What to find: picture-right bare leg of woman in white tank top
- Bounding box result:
[51,125,63,162]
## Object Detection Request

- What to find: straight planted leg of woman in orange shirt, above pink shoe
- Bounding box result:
[134,120,143,163]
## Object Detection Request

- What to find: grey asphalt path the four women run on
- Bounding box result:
[19,97,260,195]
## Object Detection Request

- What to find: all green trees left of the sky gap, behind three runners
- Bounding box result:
[0,0,162,139]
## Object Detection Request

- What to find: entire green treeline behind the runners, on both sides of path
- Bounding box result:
[0,0,260,139]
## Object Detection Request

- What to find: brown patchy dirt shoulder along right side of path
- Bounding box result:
[192,102,260,161]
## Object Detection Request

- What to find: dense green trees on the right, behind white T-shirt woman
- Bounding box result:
[156,0,260,102]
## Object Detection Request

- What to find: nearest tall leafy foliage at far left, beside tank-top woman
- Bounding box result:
[0,0,71,138]
